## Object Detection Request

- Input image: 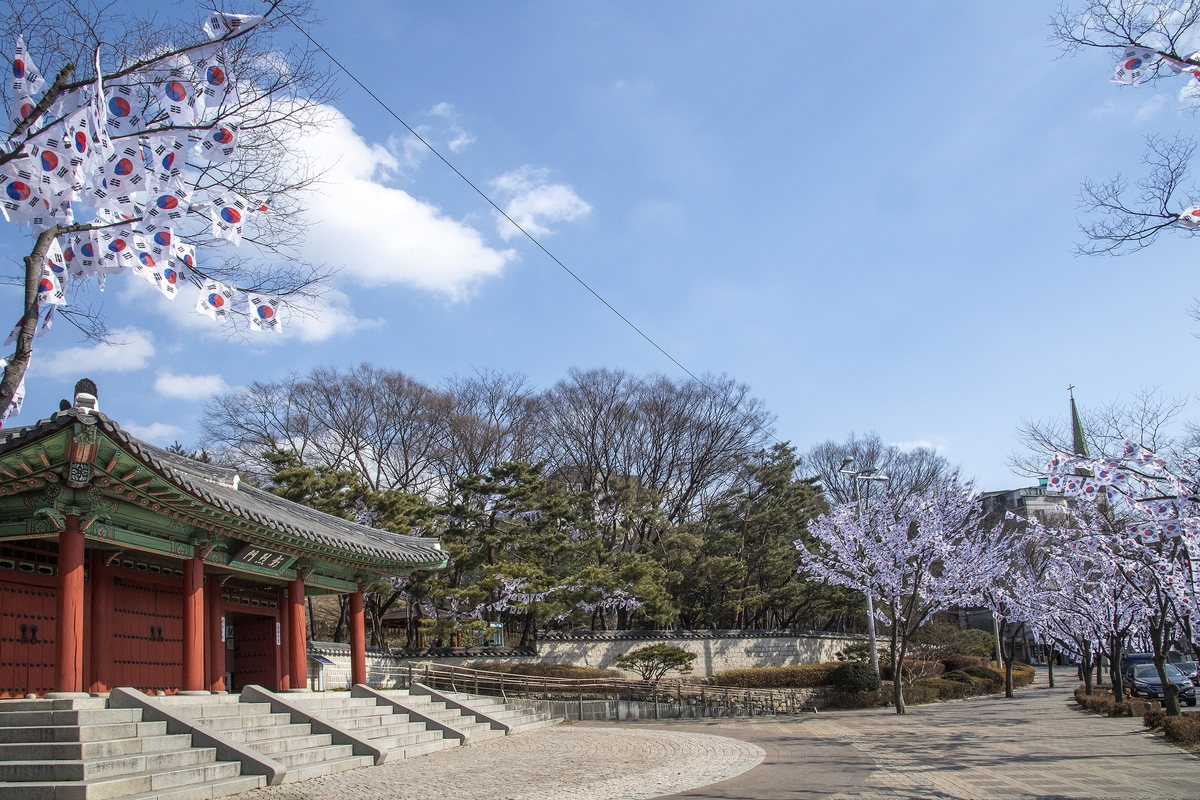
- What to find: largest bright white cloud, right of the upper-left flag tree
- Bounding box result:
[300,108,515,299]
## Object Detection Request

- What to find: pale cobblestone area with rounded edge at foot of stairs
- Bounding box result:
[236,724,764,800]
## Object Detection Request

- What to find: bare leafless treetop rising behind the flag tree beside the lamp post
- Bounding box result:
[804,431,954,505]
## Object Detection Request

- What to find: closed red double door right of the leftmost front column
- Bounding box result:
[113,576,184,691]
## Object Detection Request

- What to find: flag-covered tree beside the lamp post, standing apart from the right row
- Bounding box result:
[796,476,997,714]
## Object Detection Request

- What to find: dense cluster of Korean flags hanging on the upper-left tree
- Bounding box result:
[0,12,281,344]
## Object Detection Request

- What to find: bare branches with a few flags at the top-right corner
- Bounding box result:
[1051,0,1200,255]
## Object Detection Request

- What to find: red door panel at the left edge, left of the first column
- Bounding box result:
[0,571,55,697]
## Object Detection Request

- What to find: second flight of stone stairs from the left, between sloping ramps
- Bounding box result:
[156,694,374,783]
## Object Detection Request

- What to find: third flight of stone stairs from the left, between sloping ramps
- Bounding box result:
[287,692,460,763]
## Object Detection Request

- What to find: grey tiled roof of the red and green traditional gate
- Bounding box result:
[0,408,445,566]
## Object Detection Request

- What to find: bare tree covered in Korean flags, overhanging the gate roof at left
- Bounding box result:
[0,0,331,415]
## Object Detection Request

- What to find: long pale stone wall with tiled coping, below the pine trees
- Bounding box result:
[308,631,865,690]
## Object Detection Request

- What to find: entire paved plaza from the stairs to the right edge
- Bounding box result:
[231,672,1200,800]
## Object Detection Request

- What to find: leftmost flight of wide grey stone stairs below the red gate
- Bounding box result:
[0,698,265,800]
